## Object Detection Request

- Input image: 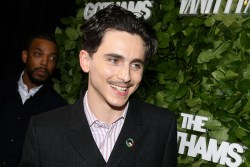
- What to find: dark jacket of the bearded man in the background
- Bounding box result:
[0,75,67,167]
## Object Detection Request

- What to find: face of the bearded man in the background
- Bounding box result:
[22,39,58,85]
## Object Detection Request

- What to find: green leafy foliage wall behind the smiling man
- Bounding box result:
[53,0,250,167]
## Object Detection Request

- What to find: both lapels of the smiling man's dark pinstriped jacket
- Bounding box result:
[62,98,147,167]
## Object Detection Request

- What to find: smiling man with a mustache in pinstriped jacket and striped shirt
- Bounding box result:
[20,5,177,167]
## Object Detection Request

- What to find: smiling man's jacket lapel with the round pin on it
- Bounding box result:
[107,102,147,166]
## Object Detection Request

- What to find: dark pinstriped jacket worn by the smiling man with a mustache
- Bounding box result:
[20,98,177,167]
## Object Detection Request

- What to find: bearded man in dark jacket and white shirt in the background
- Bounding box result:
[0,34,67,167]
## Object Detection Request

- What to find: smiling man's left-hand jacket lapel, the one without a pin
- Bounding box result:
[65,98,106,167]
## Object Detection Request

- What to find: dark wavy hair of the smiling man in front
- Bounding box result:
[81,4,157,58]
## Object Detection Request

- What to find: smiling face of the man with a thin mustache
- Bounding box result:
[80,30,145,108]
